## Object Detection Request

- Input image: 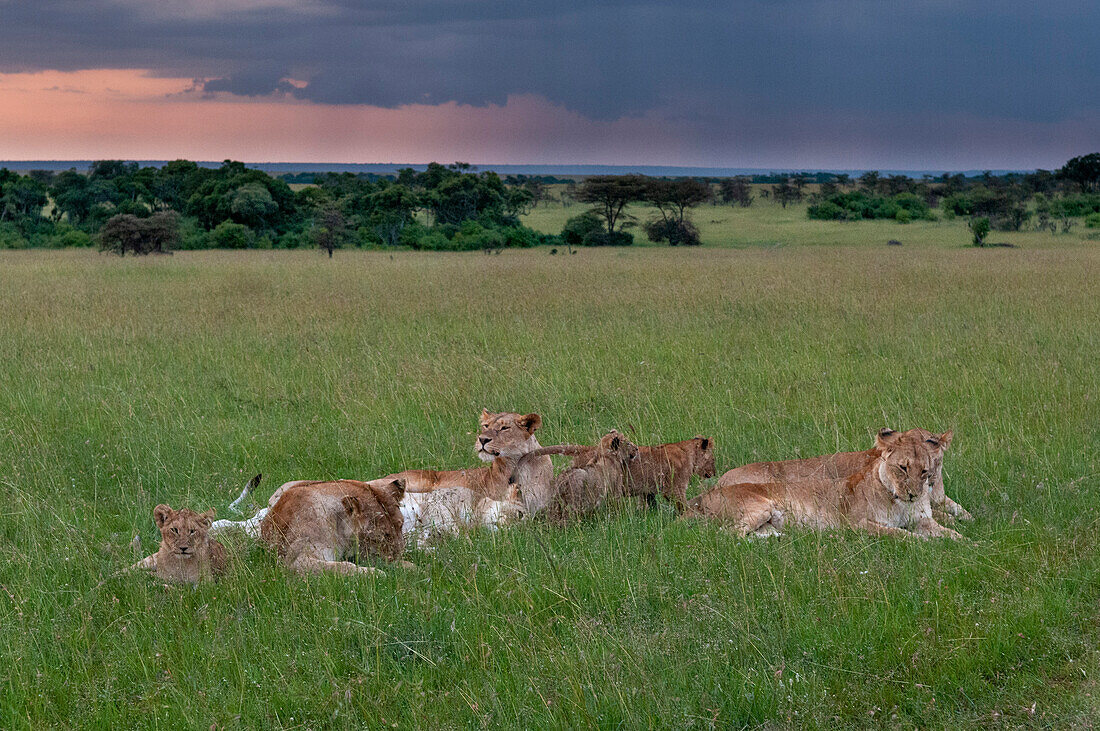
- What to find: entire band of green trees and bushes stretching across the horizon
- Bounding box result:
[0,153,1100,250]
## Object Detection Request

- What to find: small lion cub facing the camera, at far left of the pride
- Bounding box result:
[131,505,228,584]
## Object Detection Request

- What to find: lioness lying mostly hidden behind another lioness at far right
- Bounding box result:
[718,429,971,520]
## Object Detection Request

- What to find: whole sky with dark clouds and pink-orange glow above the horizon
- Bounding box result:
[0,0,1100,169]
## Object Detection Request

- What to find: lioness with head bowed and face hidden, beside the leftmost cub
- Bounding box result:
[260,479,405,574]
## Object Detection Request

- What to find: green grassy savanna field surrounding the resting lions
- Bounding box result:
[0,215,1100,729]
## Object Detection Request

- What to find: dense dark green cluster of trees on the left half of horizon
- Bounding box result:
[0,160,557,255]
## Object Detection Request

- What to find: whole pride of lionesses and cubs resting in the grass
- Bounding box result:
[132,410,970,583]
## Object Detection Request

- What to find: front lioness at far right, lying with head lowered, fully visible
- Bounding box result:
[688,429,963,539]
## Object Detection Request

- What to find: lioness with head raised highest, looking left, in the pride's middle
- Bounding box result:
[372,409,553,512]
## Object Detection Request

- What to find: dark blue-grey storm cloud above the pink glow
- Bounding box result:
[0,0,1100,129]
